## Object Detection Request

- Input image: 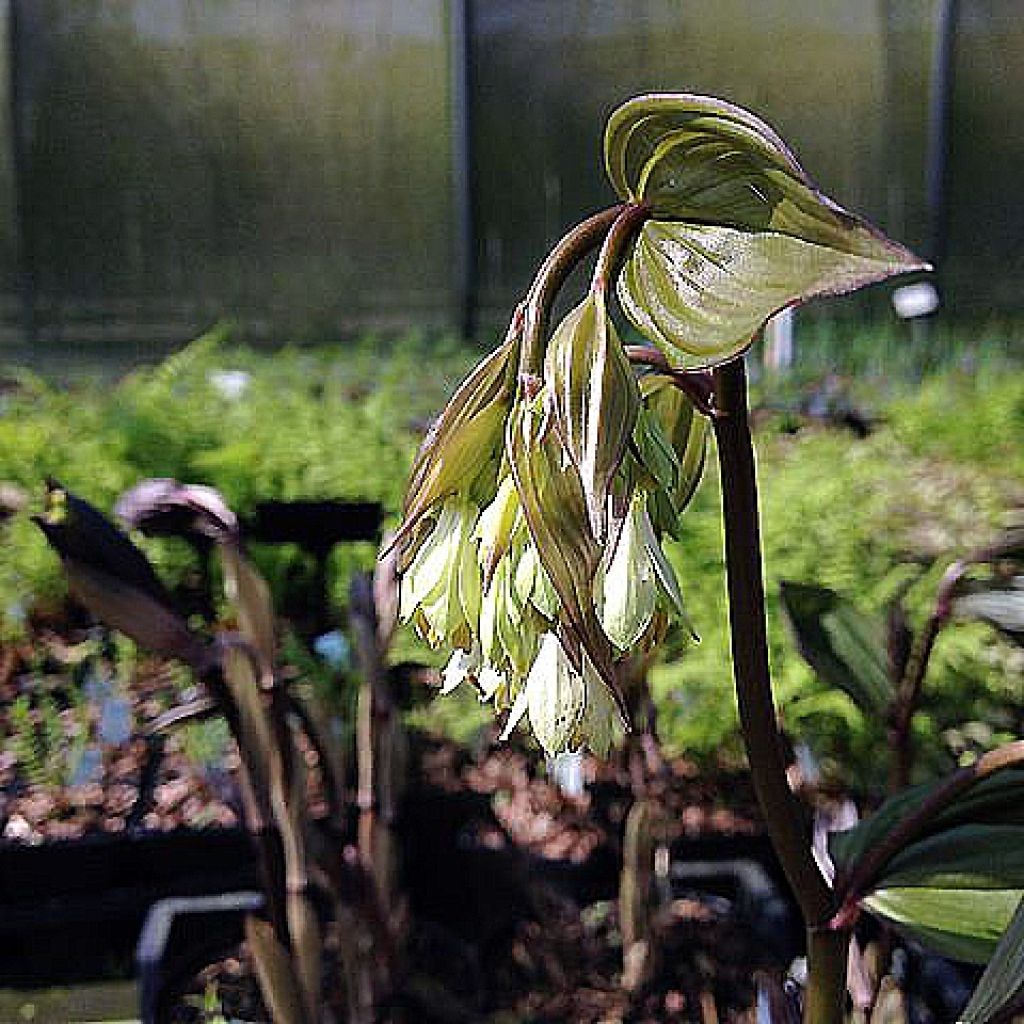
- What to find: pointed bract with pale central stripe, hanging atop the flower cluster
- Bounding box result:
[544,293,640,542]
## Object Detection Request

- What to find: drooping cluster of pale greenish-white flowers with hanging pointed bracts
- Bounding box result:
[396,293,705,755]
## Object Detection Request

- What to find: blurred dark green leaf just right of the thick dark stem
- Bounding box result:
[780,581,893,716]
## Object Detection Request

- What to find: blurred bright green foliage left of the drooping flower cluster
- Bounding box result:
[0,331,474,631]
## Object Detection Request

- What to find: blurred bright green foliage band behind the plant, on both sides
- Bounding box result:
[0,325,1024,788]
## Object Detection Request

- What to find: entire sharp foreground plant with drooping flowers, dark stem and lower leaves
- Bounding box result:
[393,94,1024,1024]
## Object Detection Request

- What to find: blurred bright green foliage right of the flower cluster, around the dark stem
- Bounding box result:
[652,364,1024,778]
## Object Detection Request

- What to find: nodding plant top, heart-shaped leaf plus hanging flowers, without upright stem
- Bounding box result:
[395,95,922,755]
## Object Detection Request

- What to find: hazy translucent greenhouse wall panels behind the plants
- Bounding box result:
[0,0,1024,342]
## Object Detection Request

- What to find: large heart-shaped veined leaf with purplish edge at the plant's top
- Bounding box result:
[604,93,926,366]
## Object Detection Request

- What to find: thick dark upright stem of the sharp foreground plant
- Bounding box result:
[712,359,847,1024]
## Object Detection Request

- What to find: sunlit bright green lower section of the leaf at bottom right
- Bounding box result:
[864,888,1024,964]
